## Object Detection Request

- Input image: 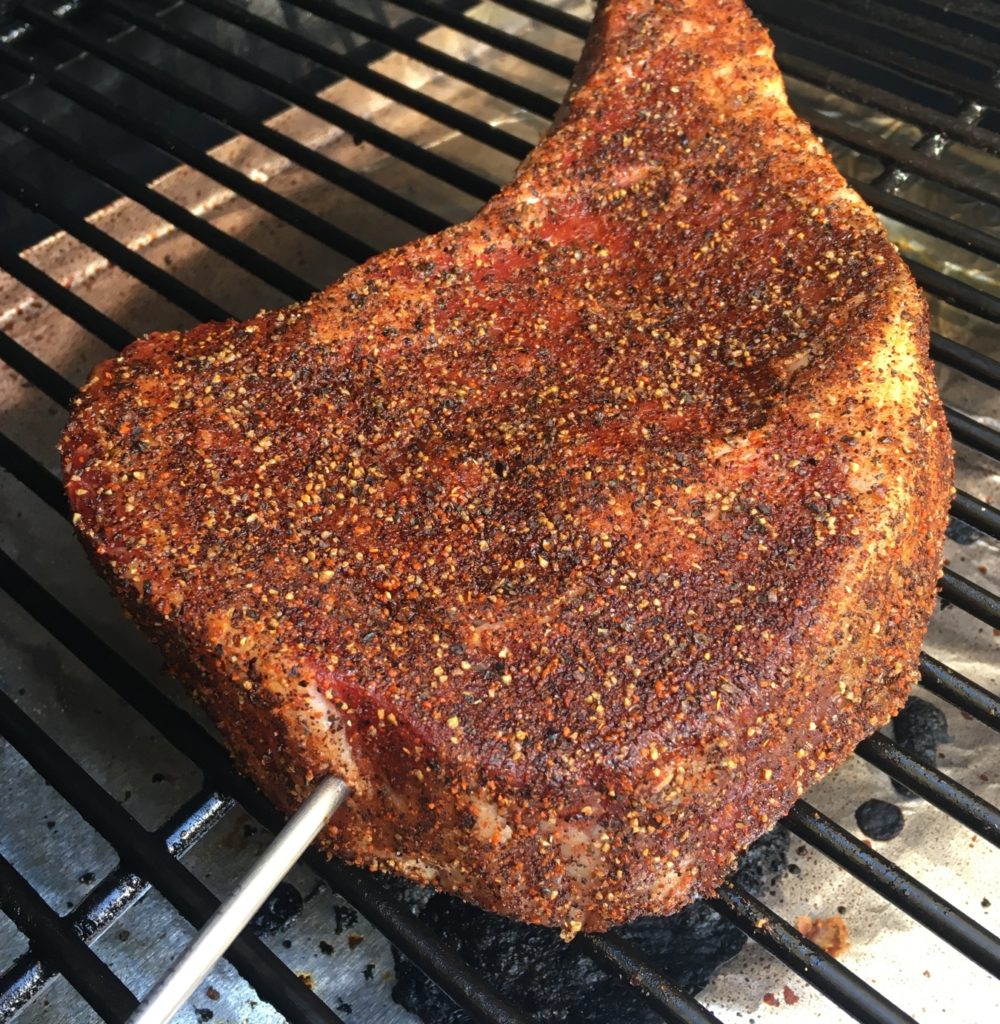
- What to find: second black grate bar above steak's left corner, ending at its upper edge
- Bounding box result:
[0,165,231,321]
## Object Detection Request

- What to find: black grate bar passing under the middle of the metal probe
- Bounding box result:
[0,692,352,1024]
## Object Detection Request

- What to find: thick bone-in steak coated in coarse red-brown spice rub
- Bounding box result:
[62,0,951,933]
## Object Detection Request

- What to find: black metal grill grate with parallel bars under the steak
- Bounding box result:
[0,0,1000,1024]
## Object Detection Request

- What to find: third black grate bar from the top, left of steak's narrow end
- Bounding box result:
[291,0,559,118]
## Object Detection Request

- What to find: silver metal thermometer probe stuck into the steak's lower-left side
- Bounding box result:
[128,775,351,1024]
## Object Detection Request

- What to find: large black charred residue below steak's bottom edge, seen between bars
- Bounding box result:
[392,827,788,1024]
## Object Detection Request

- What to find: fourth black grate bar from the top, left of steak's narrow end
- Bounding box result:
[188,0,532,160]
